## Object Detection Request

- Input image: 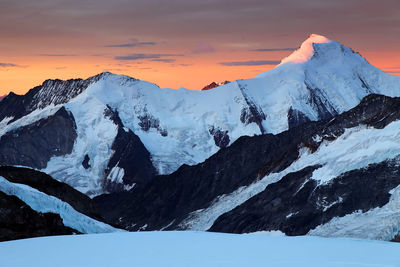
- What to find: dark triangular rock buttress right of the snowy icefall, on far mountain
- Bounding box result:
[103,107,156,195]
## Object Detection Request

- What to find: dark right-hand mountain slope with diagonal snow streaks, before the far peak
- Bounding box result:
[95,95,400,240]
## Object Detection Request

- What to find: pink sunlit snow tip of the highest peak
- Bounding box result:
[281,34,332,64]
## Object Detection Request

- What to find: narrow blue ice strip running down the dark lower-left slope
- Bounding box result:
[0,176,121,236]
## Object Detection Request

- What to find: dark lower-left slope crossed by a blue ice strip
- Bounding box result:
[0,167,118,240]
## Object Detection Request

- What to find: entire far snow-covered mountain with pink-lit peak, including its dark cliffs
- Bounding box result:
[0,35,400,196]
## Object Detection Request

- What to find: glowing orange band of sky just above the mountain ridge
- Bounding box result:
[0,48,400,95]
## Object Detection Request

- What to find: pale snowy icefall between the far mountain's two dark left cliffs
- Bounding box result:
[42,95,117,196]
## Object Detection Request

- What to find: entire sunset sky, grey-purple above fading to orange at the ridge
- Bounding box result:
[0,0,400,95]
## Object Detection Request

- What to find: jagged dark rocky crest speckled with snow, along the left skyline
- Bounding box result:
[0,72,110,122]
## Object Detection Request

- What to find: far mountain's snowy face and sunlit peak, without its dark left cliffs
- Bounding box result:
[0,35,400,196]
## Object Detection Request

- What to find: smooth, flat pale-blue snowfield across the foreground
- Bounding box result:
[0,232,400,267]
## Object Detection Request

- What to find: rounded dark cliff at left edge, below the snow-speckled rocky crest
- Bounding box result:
[0,107,77,169]
